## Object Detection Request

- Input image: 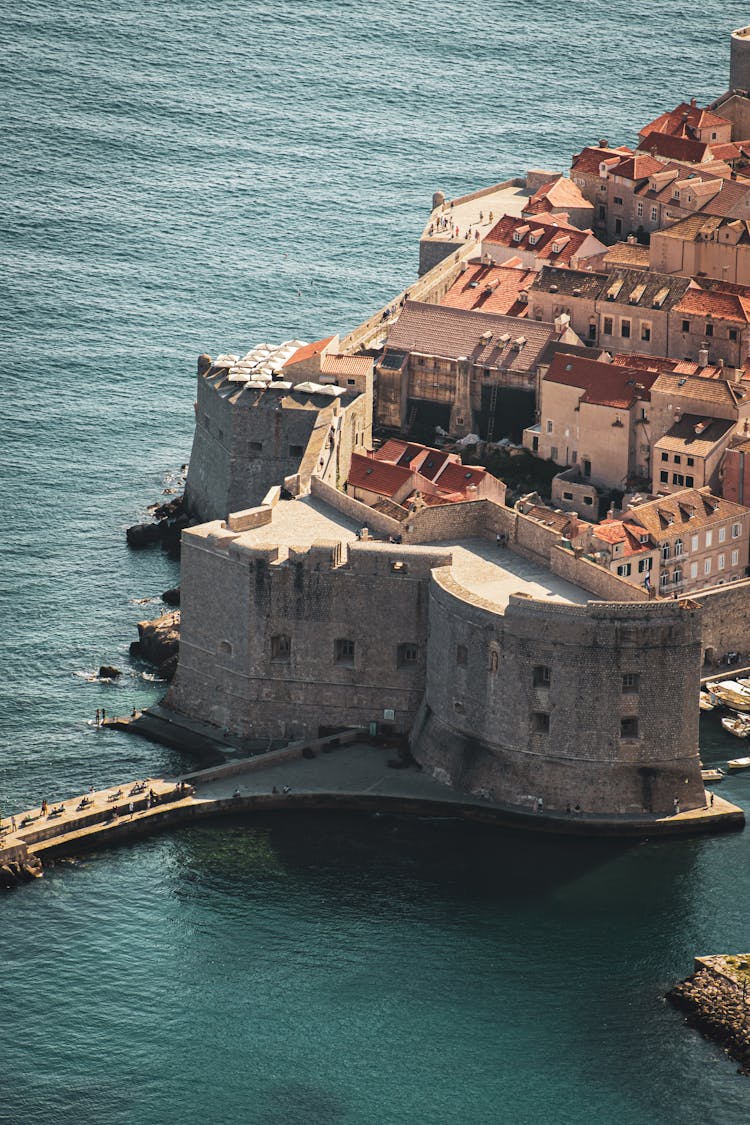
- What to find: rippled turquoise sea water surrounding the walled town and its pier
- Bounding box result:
[0,0,750,1125]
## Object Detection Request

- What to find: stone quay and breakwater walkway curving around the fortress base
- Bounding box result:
[0,720,744,886]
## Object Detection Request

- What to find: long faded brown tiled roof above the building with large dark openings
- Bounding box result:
[388,300,555,371]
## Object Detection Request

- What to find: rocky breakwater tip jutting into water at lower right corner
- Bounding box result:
[667,954,750,1076]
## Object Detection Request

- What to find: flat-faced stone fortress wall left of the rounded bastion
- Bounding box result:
[165,532,434,738]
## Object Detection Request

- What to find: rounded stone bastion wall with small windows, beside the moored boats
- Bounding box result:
[413,570,705,813]
